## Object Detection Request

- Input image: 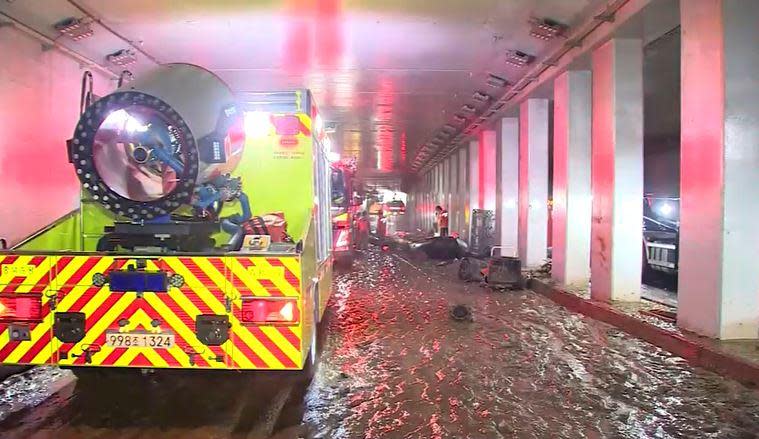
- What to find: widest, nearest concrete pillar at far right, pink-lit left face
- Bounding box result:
[677,0,759,339]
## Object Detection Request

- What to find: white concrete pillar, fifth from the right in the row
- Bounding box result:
[495,117,519,257]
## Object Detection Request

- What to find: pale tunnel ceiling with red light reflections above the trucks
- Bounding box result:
[0,0,606,178]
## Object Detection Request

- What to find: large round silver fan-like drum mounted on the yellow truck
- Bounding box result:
[68,64,247,250]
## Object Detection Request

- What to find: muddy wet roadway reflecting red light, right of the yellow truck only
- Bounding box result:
[304,253,759,438]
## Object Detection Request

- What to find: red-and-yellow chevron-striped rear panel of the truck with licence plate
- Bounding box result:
[0,254,316,370]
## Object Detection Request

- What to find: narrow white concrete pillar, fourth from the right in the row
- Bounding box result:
[519,99,548,268]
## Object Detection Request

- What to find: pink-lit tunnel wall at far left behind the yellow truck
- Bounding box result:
[0,26,112,245]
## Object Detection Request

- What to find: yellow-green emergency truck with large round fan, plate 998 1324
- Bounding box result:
[0,64,332,373]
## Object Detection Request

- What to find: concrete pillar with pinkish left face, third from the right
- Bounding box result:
[551,71,592,286]
